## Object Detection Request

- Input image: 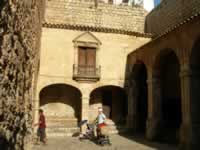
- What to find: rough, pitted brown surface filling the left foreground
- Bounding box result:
[0,0,44,150]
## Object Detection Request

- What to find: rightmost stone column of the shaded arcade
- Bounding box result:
[180,66,191,150]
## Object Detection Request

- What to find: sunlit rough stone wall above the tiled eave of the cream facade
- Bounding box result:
[45,0,147,33]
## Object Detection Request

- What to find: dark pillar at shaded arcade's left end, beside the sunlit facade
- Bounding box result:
[127,80,137,131]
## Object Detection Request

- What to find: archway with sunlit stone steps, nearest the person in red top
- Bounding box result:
[39,84,81,134]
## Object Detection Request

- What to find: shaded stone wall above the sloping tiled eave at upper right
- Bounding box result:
[145,0,200,36]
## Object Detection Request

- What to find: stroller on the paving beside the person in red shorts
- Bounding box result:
[79,120,111,146]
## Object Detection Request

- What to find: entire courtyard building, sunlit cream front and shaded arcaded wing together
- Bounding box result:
[30,0,200,150]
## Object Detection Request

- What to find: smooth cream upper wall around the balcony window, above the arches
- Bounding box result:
[36,28,150,92]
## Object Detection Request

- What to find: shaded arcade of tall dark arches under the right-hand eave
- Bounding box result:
[128,23,200,150]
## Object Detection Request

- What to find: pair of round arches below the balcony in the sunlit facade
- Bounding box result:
[36,84,127,136]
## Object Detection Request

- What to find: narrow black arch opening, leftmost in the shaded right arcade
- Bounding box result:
[131,63,148,136]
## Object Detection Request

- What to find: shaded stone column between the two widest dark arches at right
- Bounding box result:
[146,73,162,140]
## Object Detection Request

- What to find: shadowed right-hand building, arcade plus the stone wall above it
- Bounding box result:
[127,0,200,150]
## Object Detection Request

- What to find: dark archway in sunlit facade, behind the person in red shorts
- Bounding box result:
[90,86,127,131]
